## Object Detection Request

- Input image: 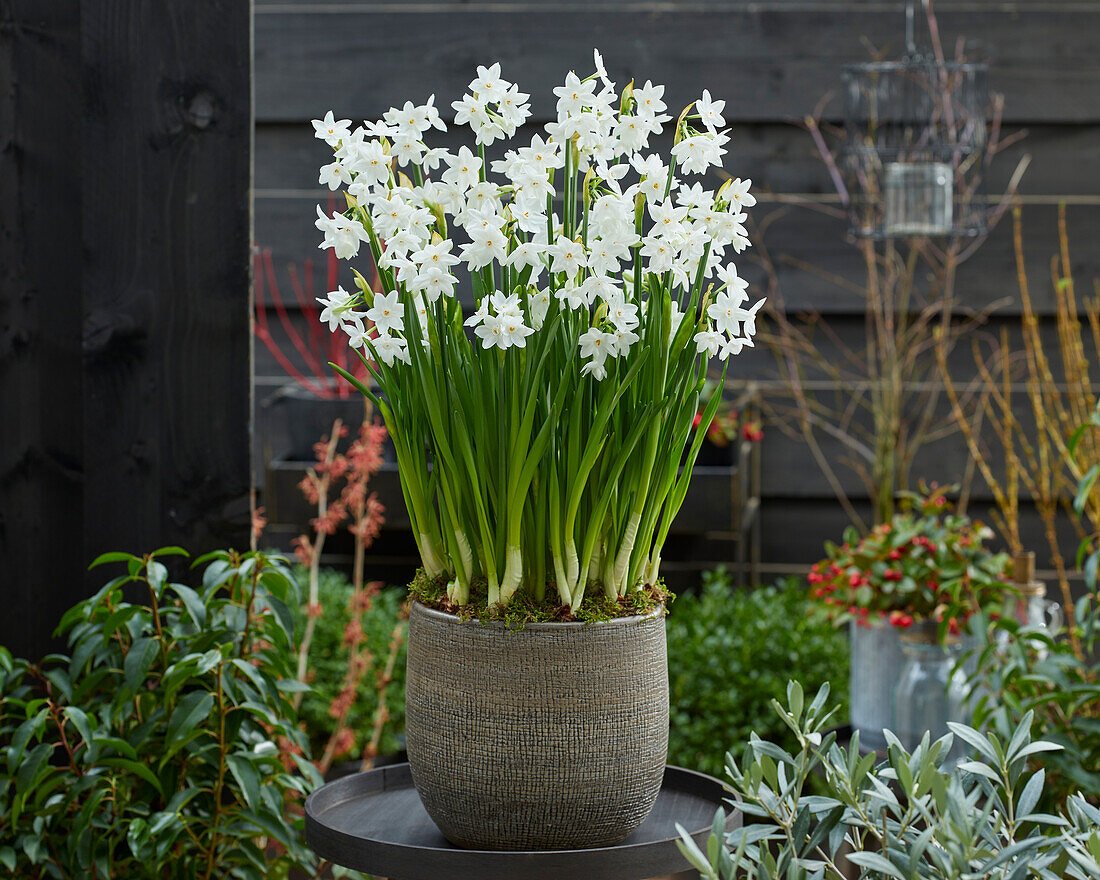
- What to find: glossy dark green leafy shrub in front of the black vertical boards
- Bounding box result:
[0,548,338,880]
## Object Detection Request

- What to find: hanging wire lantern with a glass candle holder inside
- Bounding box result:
[843,6,989,239]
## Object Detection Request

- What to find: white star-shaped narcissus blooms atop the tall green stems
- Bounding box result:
[314,52,762,371]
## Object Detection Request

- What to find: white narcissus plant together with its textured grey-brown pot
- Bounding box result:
[314,53,762,849]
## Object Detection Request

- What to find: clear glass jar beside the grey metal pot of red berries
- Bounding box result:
[894,625,967,768]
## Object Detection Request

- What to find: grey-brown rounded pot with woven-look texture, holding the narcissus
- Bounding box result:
[405,603,669,850]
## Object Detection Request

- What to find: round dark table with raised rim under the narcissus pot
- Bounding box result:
[306,763,741,880]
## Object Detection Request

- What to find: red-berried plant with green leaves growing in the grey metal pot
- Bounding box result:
[809,484,1011,638]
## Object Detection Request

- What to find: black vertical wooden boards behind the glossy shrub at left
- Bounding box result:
[0,0,252,657]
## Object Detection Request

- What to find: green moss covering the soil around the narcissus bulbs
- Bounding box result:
[409,569,675,629]
